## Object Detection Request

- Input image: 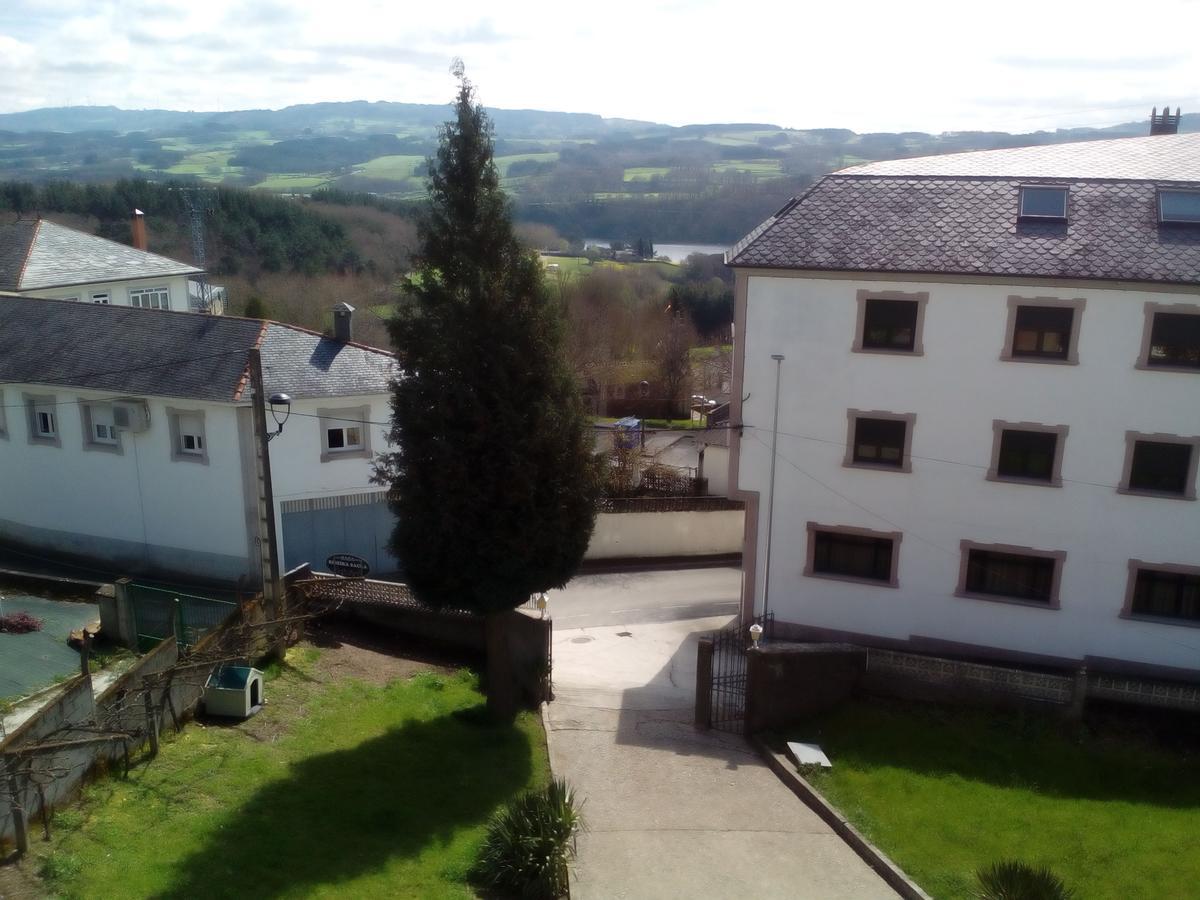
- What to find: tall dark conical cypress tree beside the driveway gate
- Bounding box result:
[380,62,599,628]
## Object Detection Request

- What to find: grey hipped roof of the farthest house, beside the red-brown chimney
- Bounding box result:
[0,218,203,290]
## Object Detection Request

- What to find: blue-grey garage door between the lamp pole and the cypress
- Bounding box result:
[280,491,400,576]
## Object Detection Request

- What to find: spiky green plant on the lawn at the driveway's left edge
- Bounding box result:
[474,779,583,900]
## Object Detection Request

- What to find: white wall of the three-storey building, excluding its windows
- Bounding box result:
[734,275,1200,668]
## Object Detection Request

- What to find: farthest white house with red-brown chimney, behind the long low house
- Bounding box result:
[0,210,224,312]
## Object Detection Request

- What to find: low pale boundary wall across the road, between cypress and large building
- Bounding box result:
[583,510,743,559]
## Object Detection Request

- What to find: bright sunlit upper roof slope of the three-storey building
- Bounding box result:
[838,133,1200,181]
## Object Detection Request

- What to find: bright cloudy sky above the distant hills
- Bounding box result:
[0,0,1200,132]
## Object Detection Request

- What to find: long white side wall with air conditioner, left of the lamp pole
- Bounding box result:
[0,384,248,578]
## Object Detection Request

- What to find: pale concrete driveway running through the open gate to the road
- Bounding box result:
[548,570,895,900]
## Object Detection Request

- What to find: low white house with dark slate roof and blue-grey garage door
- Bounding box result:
[0,296,396,583]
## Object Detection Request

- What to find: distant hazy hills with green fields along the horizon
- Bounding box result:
[0,101,1200,242]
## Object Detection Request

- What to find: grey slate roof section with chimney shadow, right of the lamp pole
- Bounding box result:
[263,322,397,398]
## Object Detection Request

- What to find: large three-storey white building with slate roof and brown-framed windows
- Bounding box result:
[727,134,1200,679]
